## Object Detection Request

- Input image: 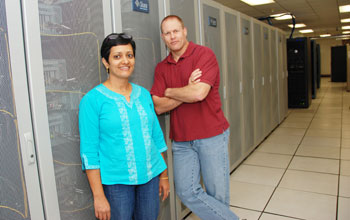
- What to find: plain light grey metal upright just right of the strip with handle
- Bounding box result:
[22,0,60,220]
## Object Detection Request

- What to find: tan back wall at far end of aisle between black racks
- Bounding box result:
[316,39,343,75]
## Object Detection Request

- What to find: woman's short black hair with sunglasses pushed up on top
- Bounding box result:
[101,33,136,62]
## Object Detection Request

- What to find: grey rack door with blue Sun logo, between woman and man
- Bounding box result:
[115,0,175,220]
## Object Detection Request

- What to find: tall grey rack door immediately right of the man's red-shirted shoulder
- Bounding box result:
[224,12,243,170]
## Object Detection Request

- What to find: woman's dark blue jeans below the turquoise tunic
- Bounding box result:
[103,176,159,220]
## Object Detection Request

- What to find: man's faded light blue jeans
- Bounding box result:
[172,129,238,220]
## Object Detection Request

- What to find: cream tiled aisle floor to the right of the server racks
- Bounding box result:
[186,78,350,220]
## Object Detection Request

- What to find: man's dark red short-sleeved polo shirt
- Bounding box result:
[151,42,229,141]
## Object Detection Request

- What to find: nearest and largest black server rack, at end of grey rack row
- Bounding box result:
[287,37,311,108]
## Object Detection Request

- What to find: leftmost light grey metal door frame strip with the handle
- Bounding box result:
[5,0,44,220]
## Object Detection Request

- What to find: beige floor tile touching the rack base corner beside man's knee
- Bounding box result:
[231,165,284,186]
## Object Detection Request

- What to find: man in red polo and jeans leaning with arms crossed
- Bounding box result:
[151,15,238,220]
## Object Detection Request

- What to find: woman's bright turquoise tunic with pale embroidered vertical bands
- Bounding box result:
[79,83,167,185]
